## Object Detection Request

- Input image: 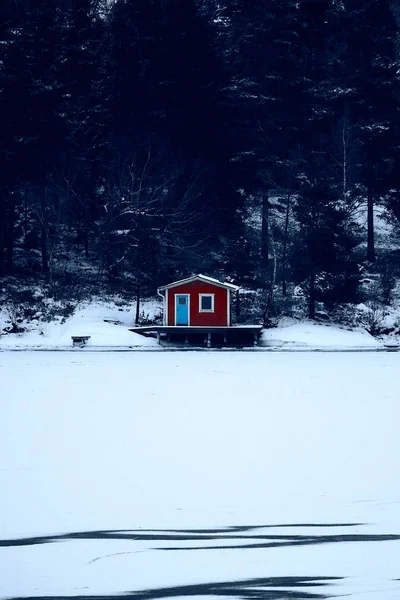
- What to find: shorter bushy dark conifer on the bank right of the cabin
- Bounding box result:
[291,154,359,319]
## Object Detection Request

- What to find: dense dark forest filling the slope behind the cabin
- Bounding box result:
[0,0,400,319]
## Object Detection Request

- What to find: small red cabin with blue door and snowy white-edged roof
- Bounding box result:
[157,275,239,327]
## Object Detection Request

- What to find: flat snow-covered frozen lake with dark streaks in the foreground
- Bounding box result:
[0,351,400,600]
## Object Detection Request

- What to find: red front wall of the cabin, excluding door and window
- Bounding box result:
[166,281,229,327]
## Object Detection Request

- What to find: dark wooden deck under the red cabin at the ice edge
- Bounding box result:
[129,325,262,348]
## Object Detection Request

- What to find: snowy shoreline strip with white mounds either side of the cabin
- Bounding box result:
[0,300,400,353]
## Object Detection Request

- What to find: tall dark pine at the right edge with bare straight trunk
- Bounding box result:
[344,0,399,261]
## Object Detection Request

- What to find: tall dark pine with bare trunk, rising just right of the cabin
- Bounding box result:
[219,0,304,278]
